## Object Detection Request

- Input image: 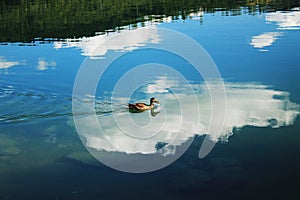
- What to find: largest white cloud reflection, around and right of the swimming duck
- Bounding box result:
[74,77,299,155]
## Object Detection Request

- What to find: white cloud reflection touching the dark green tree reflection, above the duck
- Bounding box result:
[53,9,204,58]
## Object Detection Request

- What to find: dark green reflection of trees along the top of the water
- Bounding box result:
[0,0,300,42]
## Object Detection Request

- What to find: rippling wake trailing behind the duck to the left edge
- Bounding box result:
[0,86,127,123]
